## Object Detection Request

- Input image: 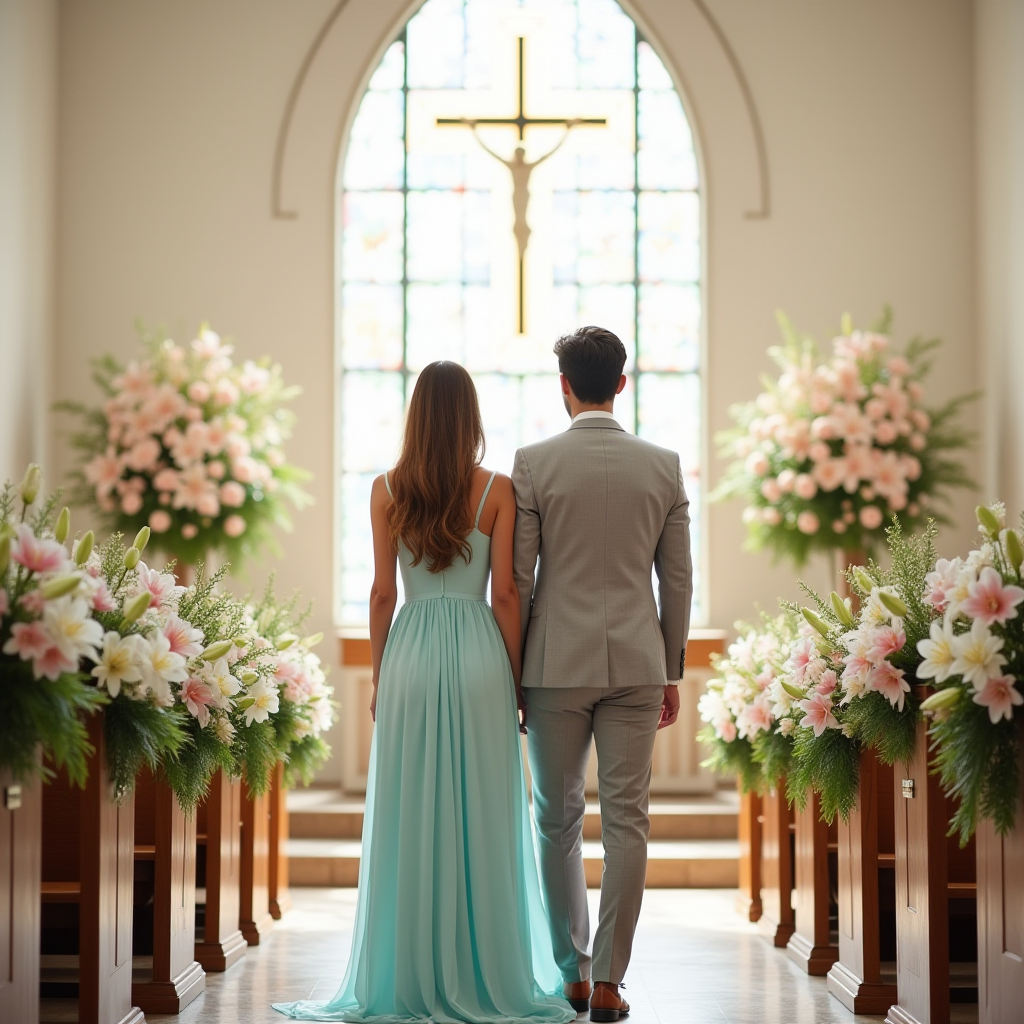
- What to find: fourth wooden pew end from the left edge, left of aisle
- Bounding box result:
[196,771,248,972]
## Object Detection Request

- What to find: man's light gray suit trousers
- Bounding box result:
[525,686,665,984]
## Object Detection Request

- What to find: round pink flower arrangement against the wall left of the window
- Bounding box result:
[62,325,308,564]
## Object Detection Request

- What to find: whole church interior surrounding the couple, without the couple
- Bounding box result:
[0,0,1024,1024]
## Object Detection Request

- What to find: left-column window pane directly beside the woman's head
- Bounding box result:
[341,371,404,473]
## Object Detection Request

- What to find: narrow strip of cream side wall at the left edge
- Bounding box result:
[0,0,57,481]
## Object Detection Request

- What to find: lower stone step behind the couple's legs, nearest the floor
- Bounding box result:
[288,839,739,889]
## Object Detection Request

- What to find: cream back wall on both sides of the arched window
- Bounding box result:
[55,0,980,778]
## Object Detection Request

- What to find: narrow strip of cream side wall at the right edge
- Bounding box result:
[975,0,1024,519]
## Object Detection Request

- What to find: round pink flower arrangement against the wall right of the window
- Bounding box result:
[713,314,973,564]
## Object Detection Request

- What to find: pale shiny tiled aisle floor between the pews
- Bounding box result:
[147,889,905,1024]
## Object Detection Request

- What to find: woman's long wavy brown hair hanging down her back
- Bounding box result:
[387,359,484,572]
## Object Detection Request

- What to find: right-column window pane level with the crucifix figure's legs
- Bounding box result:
[638,193,700,282]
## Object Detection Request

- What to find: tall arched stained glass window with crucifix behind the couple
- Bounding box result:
[337,0,702,626]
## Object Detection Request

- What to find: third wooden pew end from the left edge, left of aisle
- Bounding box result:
[132,769,206,1014]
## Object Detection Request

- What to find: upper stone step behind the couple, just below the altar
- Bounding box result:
[288,790,738,842]
